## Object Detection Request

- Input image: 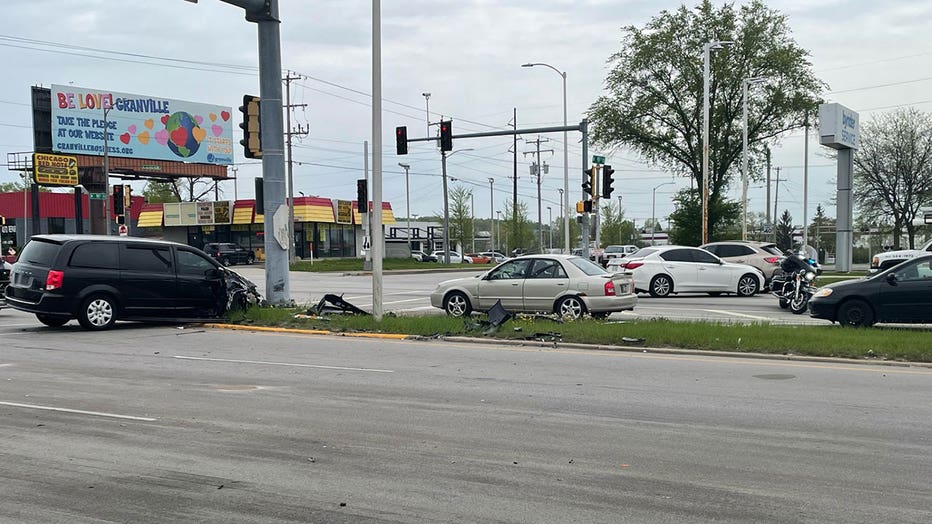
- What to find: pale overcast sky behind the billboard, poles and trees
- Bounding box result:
[0,0,932,230]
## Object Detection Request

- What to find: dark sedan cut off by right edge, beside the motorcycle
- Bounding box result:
[809,254,932,327]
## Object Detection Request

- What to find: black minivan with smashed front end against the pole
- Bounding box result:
[5,235,258,330]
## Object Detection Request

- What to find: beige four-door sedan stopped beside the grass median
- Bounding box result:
[430,255,637,318]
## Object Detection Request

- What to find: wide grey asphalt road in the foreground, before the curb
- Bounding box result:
[0,323,932,523]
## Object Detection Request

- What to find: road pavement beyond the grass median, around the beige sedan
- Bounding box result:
[232,266,829,325]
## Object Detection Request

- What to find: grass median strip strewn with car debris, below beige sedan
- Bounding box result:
[234,307,932,362]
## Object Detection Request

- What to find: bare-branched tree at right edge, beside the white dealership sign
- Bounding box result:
[854,108,932,249]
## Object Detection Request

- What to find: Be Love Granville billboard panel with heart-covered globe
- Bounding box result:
[52,84,233,165]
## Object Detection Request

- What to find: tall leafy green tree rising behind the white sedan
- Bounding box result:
[589,0,826,238]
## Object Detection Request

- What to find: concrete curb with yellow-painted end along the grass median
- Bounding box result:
[203,324,932,369]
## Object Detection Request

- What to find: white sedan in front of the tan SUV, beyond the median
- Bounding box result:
[609,246,764,297]
